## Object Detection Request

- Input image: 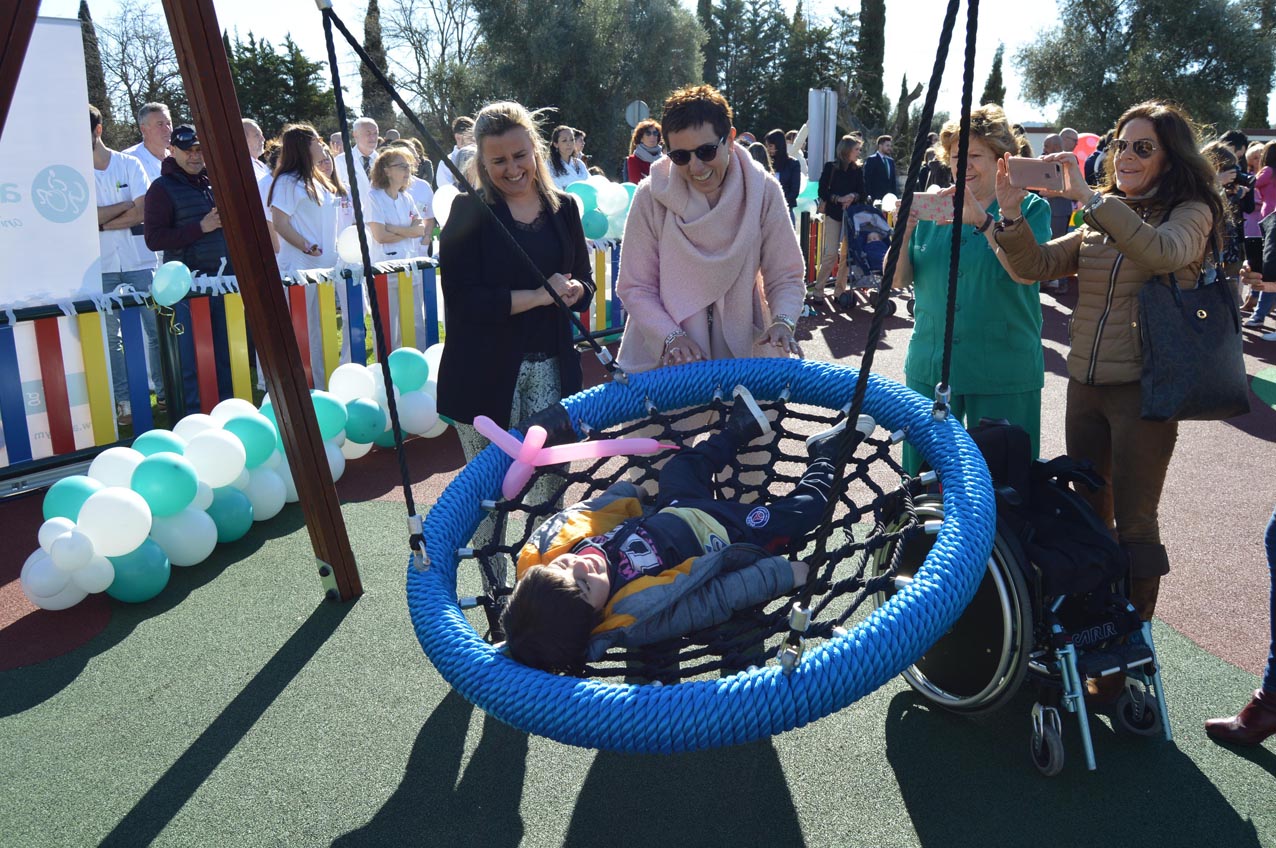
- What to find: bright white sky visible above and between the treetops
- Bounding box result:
[29,0,1127,124]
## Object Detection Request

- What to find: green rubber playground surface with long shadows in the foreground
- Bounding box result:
[0,501,1276,848]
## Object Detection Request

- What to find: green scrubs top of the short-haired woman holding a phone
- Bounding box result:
[903,194,1050,394]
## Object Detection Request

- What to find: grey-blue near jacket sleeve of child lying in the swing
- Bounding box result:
[609,556,794,647]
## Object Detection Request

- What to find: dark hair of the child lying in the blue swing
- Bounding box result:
[500,565,598,675]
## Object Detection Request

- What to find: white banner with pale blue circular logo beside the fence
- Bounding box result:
[0,18,102,309]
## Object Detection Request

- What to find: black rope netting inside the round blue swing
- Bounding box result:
[471,389,923,682]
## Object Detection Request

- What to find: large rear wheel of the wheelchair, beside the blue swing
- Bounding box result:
[873,497,1034,713]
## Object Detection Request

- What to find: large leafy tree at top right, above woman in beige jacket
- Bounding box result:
[1014,0,1270,133]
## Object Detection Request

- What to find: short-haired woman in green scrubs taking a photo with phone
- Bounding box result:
[894,105,1050,473]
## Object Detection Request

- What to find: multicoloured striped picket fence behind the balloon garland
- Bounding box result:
[0,245,624,479]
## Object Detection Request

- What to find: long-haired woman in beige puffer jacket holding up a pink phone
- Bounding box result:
[997,101,1225,620]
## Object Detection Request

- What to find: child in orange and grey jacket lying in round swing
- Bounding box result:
[501,386,872,675]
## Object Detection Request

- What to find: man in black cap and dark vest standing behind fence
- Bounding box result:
[143,124,235,421]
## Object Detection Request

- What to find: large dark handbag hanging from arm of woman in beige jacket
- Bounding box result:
[1138,244,1249,421]
